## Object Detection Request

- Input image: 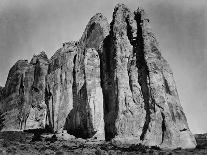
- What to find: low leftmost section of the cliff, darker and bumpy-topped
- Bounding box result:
[1,52,48,130]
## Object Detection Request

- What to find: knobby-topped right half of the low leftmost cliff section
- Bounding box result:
[24,52,49,130]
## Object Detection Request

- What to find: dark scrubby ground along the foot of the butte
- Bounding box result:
[0,132,207,155]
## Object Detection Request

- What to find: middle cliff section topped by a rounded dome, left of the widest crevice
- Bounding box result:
[46,14,109,139]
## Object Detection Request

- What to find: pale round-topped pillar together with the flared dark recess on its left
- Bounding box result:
[66,49,105,139]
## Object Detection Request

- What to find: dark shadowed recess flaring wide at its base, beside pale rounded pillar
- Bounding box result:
[64,49,96,139]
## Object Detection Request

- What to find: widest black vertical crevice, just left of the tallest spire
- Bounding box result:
[100,19,118,141]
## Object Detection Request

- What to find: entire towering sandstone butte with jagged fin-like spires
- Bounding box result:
[0,4,196,149]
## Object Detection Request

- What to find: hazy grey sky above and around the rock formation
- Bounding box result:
[0,0,207,133]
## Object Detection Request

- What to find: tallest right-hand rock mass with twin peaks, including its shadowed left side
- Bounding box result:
[103,5,196,148]
